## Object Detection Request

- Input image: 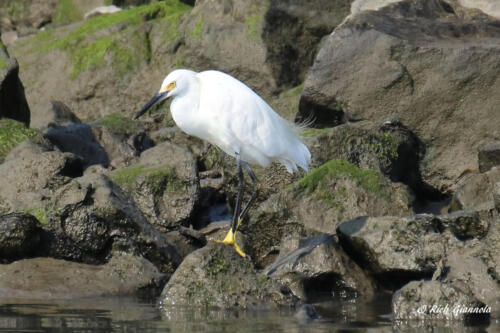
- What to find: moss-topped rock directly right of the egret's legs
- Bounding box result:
[246,159,413,265]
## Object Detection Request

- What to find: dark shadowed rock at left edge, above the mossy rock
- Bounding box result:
[0,42,30,126]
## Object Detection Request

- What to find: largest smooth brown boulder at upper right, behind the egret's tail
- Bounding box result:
[298,0,500,191]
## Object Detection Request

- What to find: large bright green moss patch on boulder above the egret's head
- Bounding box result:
[26,0,191,78]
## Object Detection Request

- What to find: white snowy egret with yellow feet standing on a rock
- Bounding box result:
[135,69,311,257]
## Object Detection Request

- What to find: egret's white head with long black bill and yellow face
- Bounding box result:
[134,69,196,119]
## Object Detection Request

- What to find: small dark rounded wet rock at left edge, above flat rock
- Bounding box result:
[0,213,42,264]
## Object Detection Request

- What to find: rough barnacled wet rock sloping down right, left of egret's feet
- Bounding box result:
[45,174,181,274]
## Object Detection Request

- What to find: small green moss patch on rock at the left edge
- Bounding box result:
[0,119,40,162]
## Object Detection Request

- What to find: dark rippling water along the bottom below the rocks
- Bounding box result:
[0,297,500,333]
